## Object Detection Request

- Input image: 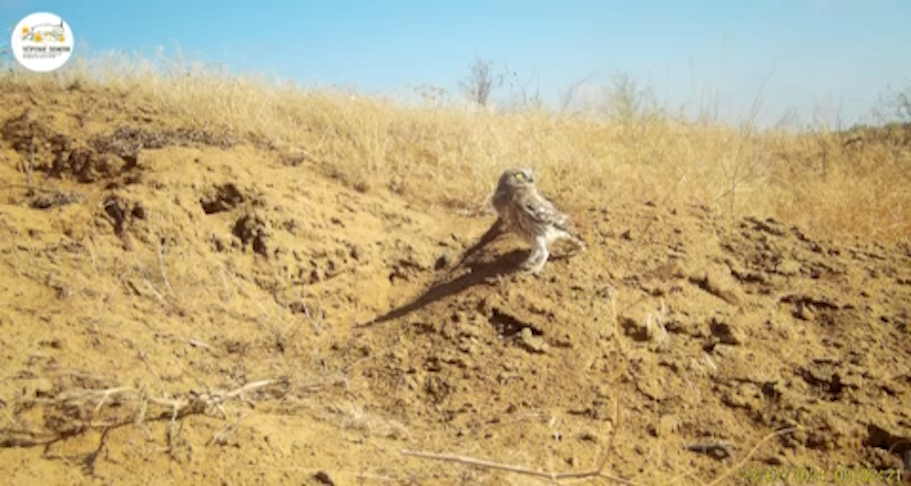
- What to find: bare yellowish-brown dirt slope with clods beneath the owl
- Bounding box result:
[0,85,911,484]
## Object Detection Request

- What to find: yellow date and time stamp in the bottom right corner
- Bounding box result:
[741,466,902,485]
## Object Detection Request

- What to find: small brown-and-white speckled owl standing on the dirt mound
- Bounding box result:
[491,167,585,275]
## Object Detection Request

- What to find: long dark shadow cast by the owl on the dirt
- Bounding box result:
[355,219,528,328]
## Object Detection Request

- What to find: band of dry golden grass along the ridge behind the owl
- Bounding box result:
[0,51,911,242]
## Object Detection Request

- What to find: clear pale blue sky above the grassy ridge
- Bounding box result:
[0,0,911,125]
